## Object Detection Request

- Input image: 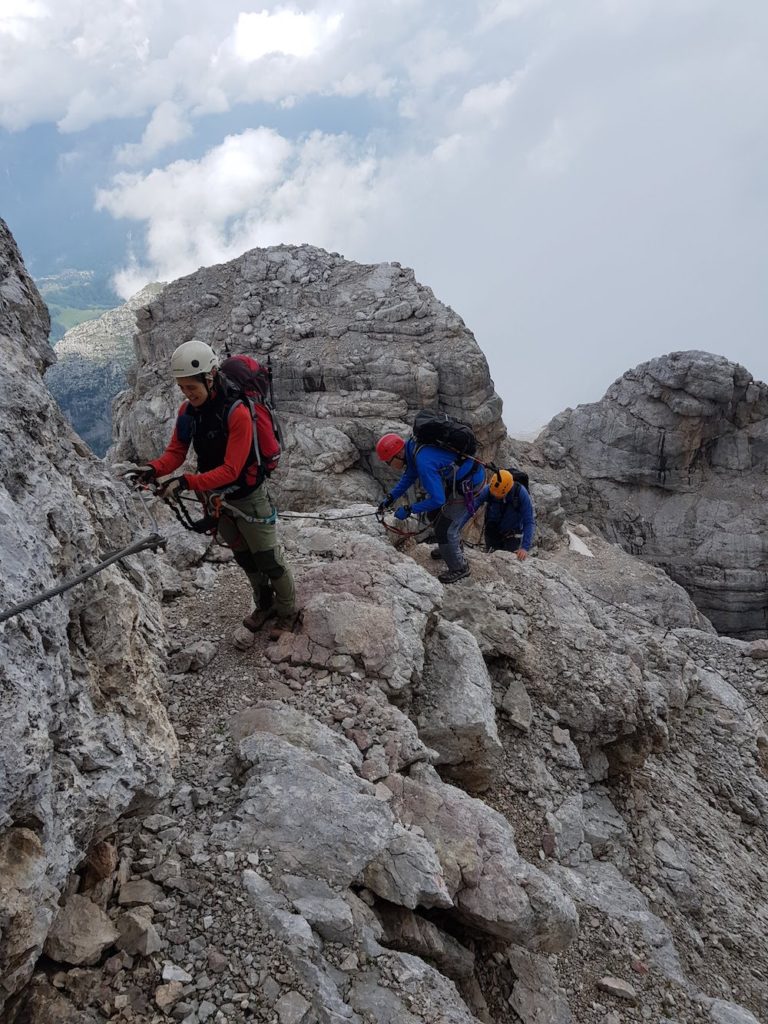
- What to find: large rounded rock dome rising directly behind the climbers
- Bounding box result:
[113,246,505,509]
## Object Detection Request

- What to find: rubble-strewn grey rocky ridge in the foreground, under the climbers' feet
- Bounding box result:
[10,506,768,1024]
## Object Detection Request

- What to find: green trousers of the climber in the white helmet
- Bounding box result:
[218,483,296,618]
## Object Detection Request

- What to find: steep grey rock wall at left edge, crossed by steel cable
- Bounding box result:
[0,221,175,1013]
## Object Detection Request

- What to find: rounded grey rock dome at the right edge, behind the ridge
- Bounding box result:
[532,351,768,638]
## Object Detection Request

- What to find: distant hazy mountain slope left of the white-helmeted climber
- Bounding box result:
[45,284,164,456]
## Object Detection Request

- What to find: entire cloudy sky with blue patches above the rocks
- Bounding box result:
[0,0,768,431]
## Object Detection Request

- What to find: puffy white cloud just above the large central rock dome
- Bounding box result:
[97,128,376,297]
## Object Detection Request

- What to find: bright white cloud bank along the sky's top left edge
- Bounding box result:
[0,0,430,132]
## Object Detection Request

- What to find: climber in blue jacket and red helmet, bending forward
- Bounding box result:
[376,434,485,583]
